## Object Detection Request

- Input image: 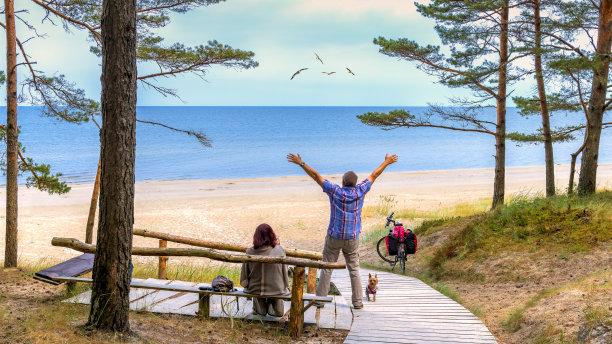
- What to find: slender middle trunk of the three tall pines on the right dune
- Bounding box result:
[533,0,555,197]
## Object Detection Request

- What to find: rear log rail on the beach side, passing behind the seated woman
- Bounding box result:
[133,229,323,260]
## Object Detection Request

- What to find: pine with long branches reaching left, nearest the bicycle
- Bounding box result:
[358,0,525,208]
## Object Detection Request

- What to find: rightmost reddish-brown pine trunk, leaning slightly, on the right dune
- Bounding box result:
[578,0,612,195]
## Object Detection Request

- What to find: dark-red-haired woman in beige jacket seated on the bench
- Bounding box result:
[240,223,289,317]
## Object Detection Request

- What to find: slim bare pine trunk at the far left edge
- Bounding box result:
[4,0,19,268]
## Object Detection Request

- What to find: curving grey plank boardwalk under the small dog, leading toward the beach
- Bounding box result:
[332,269,497,344]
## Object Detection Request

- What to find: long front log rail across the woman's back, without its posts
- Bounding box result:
[51,237,346,269]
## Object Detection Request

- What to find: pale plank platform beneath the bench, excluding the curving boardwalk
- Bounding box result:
[65,278,353,330]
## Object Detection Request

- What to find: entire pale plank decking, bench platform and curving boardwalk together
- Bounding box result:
[66,269,497,344]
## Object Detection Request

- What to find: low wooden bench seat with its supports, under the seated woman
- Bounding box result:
[54,276,333,320]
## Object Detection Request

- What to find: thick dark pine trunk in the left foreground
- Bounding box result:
[87,0,137,332]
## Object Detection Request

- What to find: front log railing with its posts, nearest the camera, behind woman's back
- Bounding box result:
[51,236,346,338]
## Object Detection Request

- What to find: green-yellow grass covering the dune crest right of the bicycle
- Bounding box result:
[426,191,612,278]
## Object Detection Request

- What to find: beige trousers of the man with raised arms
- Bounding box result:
[317,235,363,306]
